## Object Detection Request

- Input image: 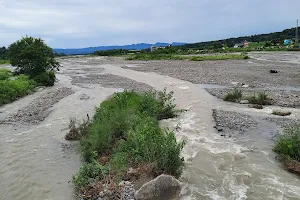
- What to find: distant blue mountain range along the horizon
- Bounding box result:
[53,42,186,55]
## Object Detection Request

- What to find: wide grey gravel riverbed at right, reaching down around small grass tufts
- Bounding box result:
[118,57,300,108]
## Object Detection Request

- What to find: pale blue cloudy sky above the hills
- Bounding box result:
[0,0,300,48]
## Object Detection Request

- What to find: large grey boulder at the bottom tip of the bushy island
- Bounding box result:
[135,175,181,200]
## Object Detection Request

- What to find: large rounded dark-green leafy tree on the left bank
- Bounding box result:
[8,36,60,78]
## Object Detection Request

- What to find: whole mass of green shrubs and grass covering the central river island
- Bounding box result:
[66,90,185,199]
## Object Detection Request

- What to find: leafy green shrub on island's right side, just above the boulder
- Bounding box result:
[119,117,185,178]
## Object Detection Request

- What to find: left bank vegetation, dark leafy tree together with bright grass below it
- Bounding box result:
[0,36,60,106]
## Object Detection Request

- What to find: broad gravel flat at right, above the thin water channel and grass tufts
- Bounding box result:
[123,60,300,87]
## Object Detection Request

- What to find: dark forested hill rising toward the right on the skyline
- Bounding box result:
[181,28,296,49]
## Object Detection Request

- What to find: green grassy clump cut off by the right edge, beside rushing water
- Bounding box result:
[274,124,300,173]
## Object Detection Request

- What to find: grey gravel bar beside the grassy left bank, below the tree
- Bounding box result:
[4,87,74,124]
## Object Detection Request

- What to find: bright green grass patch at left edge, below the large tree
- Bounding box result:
[0,69,36,106]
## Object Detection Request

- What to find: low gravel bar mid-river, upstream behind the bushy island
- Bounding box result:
[71,74,153,92]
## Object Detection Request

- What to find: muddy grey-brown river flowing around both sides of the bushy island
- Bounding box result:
[0,57,300,200]
